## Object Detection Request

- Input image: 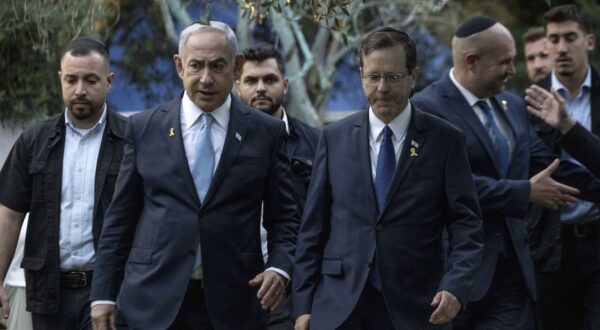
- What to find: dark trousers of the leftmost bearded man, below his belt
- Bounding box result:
[31,286,92,330]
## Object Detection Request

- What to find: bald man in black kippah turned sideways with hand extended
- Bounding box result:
[413,16,600,329]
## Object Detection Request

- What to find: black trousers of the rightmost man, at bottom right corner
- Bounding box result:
[536,221,600,330]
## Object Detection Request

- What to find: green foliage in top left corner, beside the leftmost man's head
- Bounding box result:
[0,0,110,123]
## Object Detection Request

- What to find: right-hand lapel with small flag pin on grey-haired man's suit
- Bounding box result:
[202,97,250,206]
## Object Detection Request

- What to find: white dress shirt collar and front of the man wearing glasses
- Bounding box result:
[369,102,412,183]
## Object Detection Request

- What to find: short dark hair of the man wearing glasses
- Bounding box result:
[358,27,417,72]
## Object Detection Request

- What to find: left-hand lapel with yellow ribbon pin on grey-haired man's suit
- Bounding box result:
[159,98,200,205]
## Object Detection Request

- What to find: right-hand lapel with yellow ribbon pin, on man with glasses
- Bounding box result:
[379,106,426,218]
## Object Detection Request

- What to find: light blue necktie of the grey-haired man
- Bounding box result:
[192,113,215,279]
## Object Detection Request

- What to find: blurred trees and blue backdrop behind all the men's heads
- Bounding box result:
[0,0,600,126]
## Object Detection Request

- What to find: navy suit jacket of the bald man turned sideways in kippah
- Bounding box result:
[413,72,600,301]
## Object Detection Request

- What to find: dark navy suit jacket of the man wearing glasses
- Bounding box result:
[292,107,482,329]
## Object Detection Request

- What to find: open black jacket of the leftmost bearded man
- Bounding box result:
[0,108,126,315]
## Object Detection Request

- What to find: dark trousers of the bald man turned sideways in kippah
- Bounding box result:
[452,253,534,330]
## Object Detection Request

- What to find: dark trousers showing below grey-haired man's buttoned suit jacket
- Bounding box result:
[169,280,213,330]
